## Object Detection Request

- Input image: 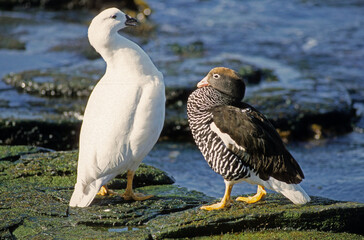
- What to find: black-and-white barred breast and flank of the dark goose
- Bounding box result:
[187,87,249,181]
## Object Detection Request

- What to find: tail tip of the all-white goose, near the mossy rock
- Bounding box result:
[69,181,101,207]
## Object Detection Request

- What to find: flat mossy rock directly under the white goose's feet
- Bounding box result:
[0,185,211,239]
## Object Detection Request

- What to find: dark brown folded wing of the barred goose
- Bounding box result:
[211,103,304,183]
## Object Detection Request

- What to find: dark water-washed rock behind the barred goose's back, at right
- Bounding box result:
[244,79,355,140]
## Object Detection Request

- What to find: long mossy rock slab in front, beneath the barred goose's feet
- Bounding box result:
[148,194,364,239]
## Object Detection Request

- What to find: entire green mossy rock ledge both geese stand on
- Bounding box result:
[0,146,364,239]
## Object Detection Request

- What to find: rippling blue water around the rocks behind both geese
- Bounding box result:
[0,0,364,202]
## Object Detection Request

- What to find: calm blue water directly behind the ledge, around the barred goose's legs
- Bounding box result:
[145,132,364,202]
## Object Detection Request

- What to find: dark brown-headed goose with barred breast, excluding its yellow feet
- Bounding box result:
[187,67,310,204]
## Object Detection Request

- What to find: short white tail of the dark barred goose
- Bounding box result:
[267,177,311,204]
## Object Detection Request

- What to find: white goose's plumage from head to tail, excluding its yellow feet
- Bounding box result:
[69,8,165,207]
